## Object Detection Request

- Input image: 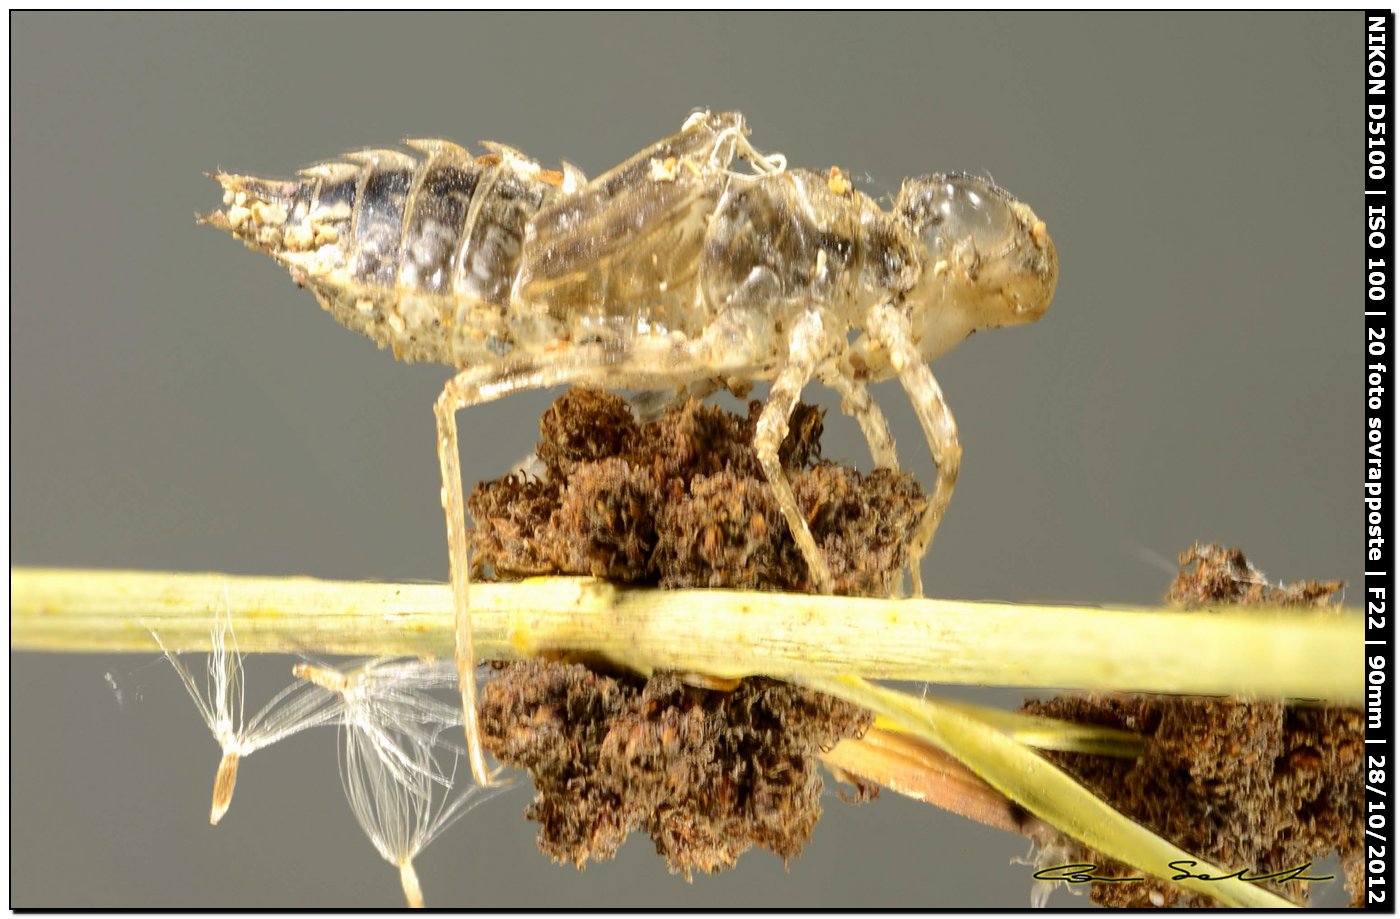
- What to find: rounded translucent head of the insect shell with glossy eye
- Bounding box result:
[895,172,1060,360]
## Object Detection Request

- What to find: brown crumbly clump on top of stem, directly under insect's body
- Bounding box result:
[468,389,925,595]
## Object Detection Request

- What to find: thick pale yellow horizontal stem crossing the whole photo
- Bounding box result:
[10,569,1362,705]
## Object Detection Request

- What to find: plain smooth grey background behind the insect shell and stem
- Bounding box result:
[10,14,1364,906]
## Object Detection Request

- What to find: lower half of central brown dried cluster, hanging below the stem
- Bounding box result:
[482,660,872,880]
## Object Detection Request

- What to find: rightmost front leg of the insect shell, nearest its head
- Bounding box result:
[865,303,962,597]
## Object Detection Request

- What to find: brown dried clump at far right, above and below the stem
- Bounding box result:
[1025,545,1364,908]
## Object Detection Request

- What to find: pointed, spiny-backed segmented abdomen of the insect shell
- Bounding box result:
[204,140,564,364]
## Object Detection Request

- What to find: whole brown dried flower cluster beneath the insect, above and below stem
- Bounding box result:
[468,389,896,878]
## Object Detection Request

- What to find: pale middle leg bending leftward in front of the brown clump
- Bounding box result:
[753,310,833,594]
